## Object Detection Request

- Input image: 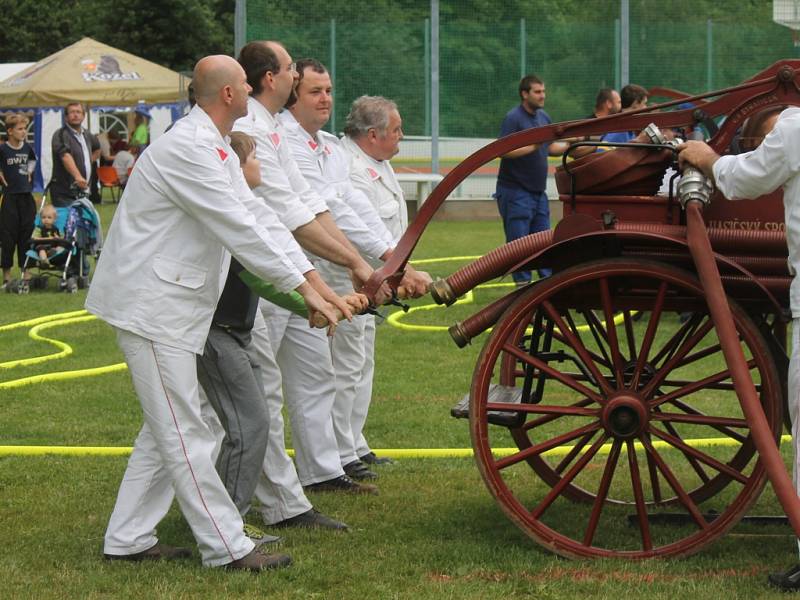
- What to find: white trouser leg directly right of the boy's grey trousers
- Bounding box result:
[251,311,311,525]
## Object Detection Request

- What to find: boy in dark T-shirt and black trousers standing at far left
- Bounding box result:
[0,114,36,294]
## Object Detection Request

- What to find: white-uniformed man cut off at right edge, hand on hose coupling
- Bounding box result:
[678,108,800,591]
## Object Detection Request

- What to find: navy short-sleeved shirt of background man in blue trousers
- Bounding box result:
[497,105,552,192]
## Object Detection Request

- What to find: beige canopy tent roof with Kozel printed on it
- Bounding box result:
[0,37,188,108]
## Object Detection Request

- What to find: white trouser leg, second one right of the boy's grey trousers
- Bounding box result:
[260,302,344,486]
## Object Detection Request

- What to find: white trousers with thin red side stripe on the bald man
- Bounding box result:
[104,329,253,567]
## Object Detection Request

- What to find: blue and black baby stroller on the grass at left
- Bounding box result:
[17,195,102,294]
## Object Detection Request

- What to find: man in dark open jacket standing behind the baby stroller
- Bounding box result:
[50,102,100,207]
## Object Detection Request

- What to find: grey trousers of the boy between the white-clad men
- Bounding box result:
[197,325,269,515]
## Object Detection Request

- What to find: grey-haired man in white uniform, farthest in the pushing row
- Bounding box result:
[339,96,408,465]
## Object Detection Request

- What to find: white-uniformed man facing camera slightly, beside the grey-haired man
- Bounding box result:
[280,59,430,480]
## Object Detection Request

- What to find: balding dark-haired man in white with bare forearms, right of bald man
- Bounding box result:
[234,41,377,502]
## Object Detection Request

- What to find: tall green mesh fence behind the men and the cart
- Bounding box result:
[242,0,798,206]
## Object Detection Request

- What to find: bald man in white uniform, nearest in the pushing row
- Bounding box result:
[86,56,335,571]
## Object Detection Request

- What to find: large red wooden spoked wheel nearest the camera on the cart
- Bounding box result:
[469,259,782,558]
